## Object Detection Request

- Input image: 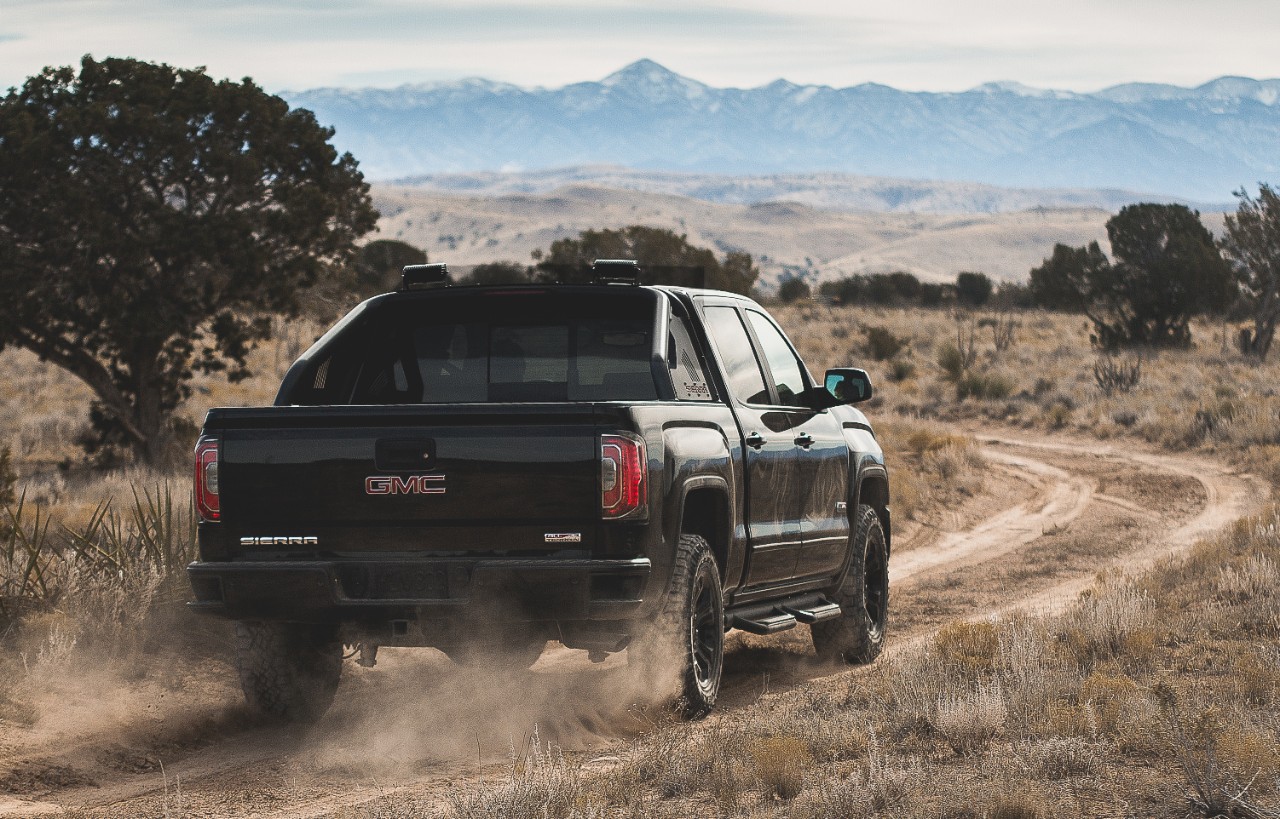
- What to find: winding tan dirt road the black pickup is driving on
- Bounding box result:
[0,431,1270,819]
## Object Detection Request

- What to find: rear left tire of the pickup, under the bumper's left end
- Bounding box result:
[236,621,342,722]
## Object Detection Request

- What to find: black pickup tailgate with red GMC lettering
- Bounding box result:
[206,404,617,537]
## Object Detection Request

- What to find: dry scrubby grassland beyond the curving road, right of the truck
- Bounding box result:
[774,303,1280,482]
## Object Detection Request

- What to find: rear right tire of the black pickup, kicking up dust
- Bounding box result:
[627,535,724,719]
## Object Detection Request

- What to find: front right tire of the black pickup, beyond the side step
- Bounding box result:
[812,504,888,664]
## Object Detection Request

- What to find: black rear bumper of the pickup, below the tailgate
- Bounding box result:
[187,558,652,623]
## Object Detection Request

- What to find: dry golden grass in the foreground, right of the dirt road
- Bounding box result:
[417,508,1280,819]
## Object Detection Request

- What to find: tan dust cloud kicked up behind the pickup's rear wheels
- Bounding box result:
[300,642,675,778]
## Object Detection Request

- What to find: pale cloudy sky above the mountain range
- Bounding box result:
[0,0,1280,91]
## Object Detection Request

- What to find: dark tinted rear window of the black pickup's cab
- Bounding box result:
[289,292,658,404]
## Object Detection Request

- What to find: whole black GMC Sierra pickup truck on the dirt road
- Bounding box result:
[188,262,891,719]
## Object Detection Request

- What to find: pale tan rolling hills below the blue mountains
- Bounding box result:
[374,184,1162,285]
